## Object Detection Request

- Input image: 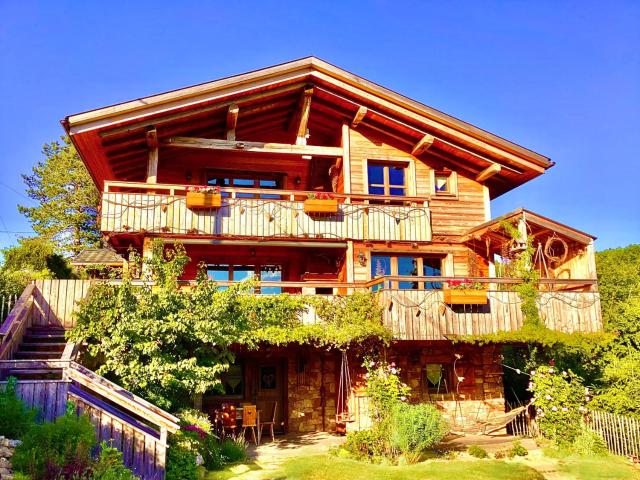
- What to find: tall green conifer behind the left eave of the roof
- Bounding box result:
[18,137,100,254]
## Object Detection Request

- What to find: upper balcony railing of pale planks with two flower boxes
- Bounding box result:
[100,182,431,242]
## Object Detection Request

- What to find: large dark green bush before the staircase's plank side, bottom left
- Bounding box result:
[12,408,96,480]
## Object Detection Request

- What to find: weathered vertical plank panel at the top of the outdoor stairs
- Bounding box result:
[31,280,91,328]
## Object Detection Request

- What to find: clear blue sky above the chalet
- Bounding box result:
[0,0,640,249]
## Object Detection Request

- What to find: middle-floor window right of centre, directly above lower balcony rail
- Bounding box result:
[371,254,442,290]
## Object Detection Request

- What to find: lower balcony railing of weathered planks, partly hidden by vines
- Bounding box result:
[18,277,602,340]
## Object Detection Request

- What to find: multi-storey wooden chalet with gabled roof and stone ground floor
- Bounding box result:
[0,57,602,464]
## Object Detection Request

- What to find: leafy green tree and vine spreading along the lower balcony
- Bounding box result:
[68,241,389,410]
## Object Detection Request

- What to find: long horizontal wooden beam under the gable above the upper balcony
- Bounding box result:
[162,137,344,157]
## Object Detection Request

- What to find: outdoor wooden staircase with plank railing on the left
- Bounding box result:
[0,280,180,480]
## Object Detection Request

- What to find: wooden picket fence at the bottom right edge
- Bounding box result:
[588,410,640,458]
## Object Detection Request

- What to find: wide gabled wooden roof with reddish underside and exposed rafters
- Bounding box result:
[62,57,553,197]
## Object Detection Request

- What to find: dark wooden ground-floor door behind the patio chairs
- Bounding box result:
[254,359,287,434]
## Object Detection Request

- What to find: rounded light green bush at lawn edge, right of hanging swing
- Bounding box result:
[390,402,449,455]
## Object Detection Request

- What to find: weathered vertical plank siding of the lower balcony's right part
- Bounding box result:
[380,289,602,340]
